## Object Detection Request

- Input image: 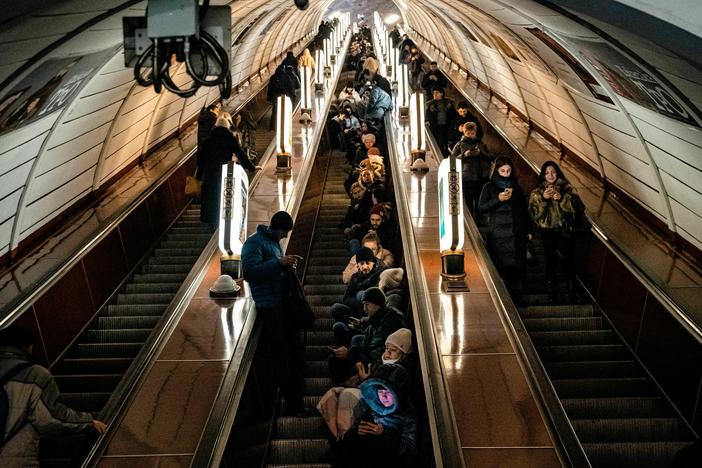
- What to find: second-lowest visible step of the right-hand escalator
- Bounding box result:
[572,418,680,443]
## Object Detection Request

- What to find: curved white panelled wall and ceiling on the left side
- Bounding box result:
[0,0,329,254]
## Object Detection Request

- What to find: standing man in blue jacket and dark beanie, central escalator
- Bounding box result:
[241,211,308,416]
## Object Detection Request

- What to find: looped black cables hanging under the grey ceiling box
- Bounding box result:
[134,0,232,99]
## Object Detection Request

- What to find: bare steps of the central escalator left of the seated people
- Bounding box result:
[268,151,349,468]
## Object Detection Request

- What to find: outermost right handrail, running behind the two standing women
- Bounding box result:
[408,32,702,344]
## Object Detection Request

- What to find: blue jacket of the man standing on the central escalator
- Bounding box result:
[241,224,289,308]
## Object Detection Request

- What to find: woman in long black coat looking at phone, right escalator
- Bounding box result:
[478,156,530,302]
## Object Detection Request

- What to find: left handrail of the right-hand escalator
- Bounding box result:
[426,121,591,468]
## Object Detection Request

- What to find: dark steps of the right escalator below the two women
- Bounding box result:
[518,239,694,468]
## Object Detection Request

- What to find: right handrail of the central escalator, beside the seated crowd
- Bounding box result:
[385,114,465,468]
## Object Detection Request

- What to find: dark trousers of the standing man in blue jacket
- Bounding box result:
[257,307,305,413]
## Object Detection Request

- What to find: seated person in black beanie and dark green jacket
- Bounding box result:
[328,287,405,384]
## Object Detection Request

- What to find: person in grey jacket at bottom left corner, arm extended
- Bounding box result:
[0,325,107,468]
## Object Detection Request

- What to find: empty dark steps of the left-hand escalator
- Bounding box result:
[41,205,212,467]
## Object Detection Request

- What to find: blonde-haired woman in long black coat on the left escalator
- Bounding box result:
[197,118,256,230]
